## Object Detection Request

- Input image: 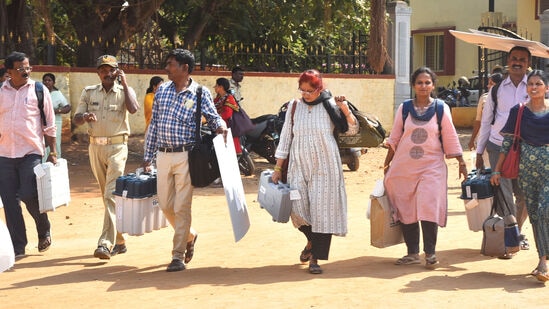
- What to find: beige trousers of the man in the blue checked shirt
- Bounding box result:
[156,151,194,260]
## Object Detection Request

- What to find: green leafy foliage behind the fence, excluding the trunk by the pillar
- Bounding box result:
[8,0,370,71]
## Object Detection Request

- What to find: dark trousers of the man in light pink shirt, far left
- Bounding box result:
[0,154,50,253]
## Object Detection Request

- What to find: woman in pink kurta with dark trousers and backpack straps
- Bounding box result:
[384,67,467,269]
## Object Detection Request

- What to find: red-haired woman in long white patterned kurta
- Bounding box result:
[273,70,358,274]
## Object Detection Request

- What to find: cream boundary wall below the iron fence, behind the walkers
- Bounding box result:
[31,66,395,134]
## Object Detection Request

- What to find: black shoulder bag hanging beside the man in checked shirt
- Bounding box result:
[189,86,221,188]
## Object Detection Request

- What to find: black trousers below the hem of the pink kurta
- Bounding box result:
[402,221,438,254]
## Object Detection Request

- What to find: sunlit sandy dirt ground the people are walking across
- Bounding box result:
[0,130,549,308]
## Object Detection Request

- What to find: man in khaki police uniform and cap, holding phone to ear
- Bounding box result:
[73,55,139,259]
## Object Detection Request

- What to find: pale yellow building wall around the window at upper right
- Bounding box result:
[410,0,516,86]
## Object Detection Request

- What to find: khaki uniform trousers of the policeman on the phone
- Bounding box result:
[89,144,128,250]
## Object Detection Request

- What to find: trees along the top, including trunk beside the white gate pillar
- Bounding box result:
[0,0,388,72]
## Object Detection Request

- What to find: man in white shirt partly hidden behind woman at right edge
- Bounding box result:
[476,46,532,254]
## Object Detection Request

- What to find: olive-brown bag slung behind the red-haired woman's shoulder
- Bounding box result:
[337,101,386,148]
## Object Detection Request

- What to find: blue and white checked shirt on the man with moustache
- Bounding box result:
[144,79,224,162]
